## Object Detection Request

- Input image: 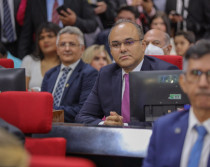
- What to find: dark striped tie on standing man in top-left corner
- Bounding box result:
[2,0,15,42]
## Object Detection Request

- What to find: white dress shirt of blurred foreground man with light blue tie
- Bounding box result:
[180,107,210,167]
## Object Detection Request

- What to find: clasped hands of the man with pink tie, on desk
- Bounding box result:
[104,111,123,126]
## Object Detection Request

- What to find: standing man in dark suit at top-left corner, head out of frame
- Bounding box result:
[0,0,21,57]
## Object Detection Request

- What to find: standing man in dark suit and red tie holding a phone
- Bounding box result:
[18,0,97,58]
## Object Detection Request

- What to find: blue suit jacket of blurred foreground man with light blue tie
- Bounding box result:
[143,110,210,167]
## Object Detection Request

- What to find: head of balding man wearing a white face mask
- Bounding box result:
[144,29,172,55]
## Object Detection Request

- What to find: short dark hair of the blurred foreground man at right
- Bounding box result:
[185,39,210,60]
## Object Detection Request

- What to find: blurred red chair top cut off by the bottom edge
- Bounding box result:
[29,156,95,167]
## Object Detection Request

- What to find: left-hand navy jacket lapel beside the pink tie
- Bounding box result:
[112,68,122,115]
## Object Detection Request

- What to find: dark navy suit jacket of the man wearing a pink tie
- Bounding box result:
[76,56,178,125]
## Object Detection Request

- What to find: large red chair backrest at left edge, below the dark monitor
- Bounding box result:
[0,91,53,133]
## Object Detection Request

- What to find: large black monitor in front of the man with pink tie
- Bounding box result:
[129,70,189,122]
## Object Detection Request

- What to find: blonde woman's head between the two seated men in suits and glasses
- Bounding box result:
[82,45,112,71]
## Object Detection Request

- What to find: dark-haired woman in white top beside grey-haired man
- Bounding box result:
[21,22,60,91]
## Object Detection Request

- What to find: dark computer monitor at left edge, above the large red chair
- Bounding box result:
[0,68,26,92]
